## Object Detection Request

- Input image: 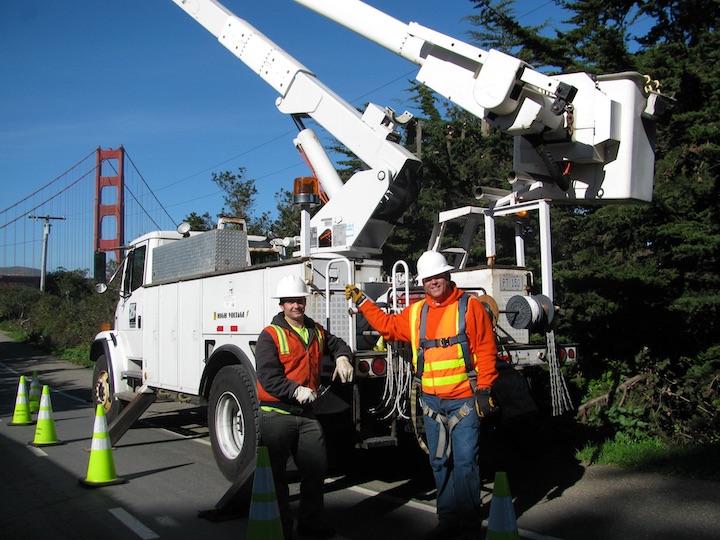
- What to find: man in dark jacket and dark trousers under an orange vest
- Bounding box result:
[255,276,353,540]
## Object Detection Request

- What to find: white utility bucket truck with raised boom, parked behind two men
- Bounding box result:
[91,0,658,483]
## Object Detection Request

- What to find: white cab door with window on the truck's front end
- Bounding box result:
[118,244,147,359]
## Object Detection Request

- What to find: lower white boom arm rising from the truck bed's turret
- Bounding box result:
[173,0,420,255]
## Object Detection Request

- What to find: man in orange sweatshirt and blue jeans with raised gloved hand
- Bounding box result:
[345,251,497,539]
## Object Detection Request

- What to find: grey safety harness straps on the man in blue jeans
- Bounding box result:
[413,293,477,460]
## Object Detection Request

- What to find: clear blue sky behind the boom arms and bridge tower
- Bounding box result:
[0,0,559,230]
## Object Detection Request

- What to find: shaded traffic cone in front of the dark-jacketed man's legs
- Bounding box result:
[245,446,283,540]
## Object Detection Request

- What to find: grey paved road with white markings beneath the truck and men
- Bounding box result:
[0,334,720,540]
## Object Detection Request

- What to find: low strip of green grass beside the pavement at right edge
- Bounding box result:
[577,435,720,481]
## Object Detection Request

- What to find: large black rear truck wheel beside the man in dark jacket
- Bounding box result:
[208,365,260,482]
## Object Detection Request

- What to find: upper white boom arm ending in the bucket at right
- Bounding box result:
[295,0,659,202]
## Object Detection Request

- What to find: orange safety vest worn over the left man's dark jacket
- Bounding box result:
[257,324,324,402]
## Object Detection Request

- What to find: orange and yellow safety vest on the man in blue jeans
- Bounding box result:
[410,293,477,399]
